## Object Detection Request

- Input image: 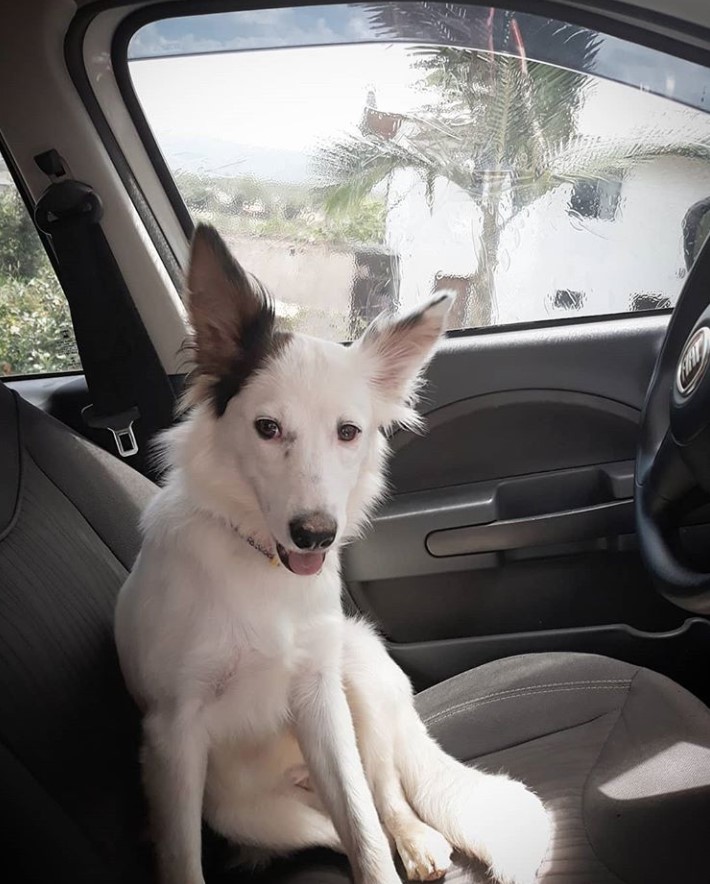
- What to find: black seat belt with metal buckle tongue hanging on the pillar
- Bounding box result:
[35,150,175,474]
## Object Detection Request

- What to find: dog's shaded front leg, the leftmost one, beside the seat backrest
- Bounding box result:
[143,709,207,884]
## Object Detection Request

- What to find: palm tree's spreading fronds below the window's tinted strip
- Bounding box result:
[317,29,710,258]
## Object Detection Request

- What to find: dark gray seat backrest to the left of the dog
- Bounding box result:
[0,384,155,884]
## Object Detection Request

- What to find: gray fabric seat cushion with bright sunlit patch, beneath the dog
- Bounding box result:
[249,653,710,884]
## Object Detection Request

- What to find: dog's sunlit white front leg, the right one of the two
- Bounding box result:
[292,627,400,884]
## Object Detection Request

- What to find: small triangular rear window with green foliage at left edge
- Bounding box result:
[0,158,81,376]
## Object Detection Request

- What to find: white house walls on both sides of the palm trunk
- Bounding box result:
[386,157,710,323]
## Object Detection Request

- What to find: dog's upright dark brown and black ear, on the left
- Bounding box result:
[187,224,280,415]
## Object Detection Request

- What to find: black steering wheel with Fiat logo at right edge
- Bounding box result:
[634,231,710,614]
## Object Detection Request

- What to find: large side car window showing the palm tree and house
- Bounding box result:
[128,3,710,339]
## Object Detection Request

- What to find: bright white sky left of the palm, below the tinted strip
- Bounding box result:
[130,44,421,157]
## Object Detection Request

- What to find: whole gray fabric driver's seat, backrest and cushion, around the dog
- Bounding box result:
[0,384,710,884]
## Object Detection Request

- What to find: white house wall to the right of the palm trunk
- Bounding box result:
[496,157,710,322]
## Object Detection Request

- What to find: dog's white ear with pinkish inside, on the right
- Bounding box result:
[357,294,454,423]
